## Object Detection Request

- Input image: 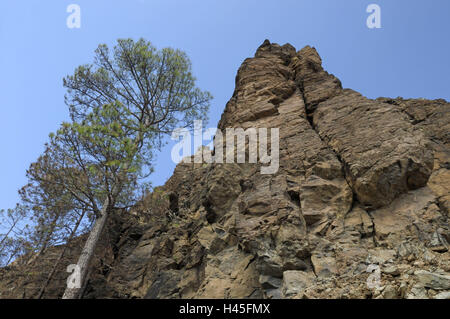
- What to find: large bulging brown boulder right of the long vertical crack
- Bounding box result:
[314,90,433,208]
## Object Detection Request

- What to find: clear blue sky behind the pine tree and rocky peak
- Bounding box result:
[0,0,450,212]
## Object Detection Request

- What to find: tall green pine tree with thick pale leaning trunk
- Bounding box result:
[40,39,211,298]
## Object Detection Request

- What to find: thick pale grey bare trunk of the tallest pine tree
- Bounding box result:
[62,198,110,299]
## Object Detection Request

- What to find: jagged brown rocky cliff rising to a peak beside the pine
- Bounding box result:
[0,41,450,298]
